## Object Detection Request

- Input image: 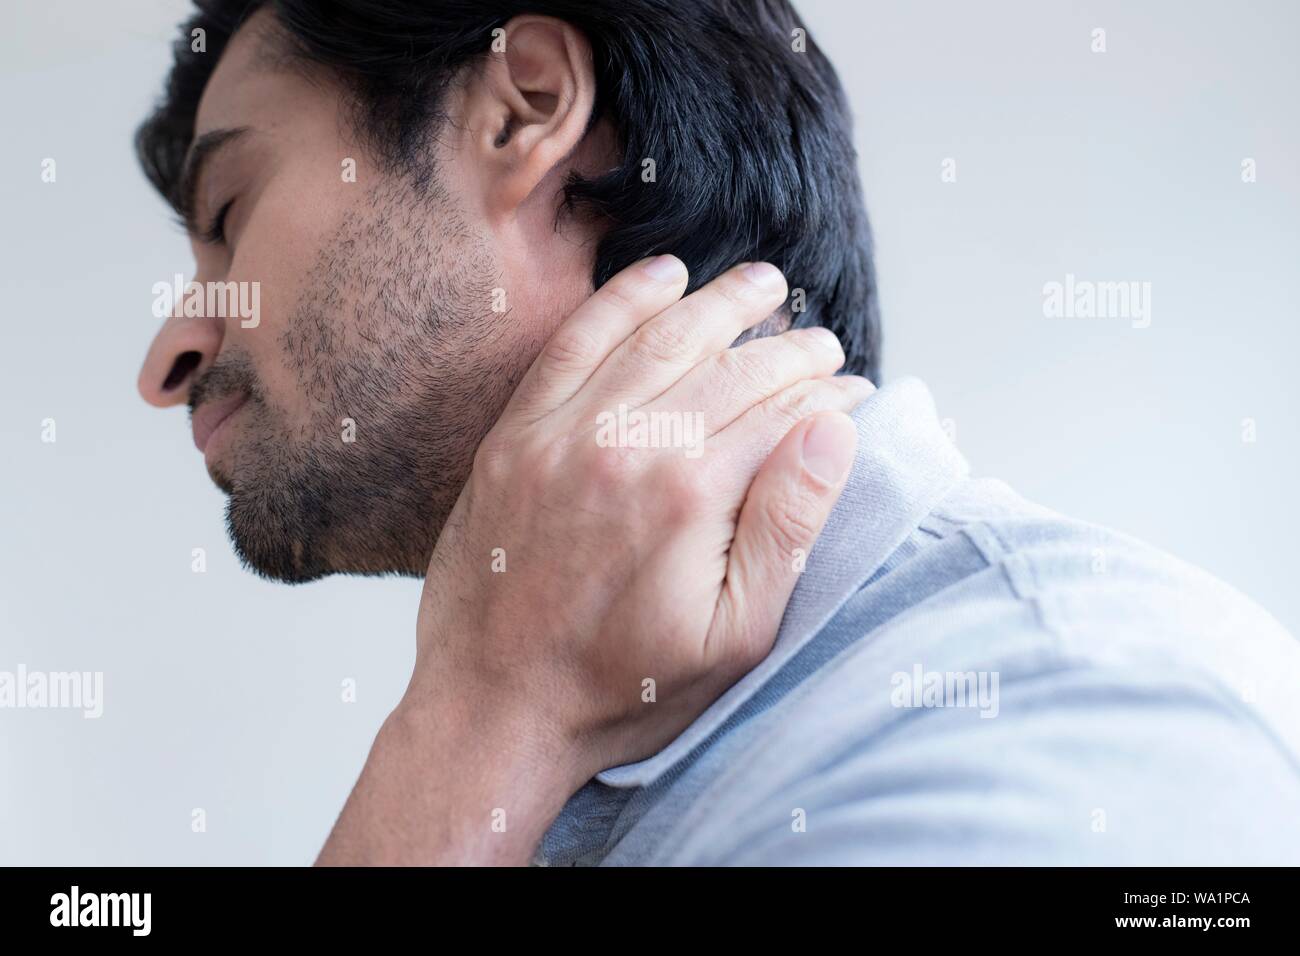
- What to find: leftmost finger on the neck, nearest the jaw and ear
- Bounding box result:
[502,255,689,425]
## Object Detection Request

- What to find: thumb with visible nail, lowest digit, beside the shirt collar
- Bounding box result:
[707,411,858,666]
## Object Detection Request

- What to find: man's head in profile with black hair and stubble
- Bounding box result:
[138,0,879,580]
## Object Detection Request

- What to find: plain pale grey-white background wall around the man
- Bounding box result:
[0,0,1300,864]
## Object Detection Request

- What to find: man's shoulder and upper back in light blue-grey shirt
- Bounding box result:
[655,489,1300,864]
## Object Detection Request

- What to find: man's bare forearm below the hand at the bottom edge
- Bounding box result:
[316,700,582,866]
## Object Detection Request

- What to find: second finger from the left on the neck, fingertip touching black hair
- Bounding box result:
[580,263,787,407]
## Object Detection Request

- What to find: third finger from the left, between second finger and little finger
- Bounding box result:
[642,326,844,438]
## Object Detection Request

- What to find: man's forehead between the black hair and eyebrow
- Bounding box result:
[194,9,338,138]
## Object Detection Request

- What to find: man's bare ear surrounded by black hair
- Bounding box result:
[465,16,595,217]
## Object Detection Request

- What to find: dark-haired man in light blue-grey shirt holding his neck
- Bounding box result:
[139,0,1300,864]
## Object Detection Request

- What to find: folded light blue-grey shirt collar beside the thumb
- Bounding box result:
[595,378,970,787]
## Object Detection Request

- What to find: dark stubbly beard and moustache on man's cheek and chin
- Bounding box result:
[190,182,527,583]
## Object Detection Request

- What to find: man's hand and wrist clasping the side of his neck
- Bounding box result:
[322,256,872,861]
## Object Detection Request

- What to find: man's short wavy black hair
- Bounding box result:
[135,0,880,380]
